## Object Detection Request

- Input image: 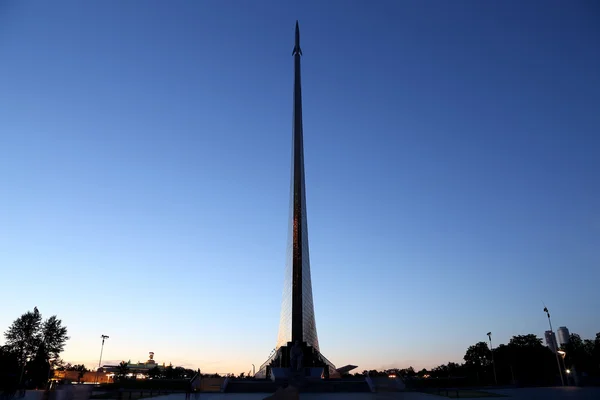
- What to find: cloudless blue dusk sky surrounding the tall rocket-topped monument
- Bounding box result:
[0,0,600,373]
